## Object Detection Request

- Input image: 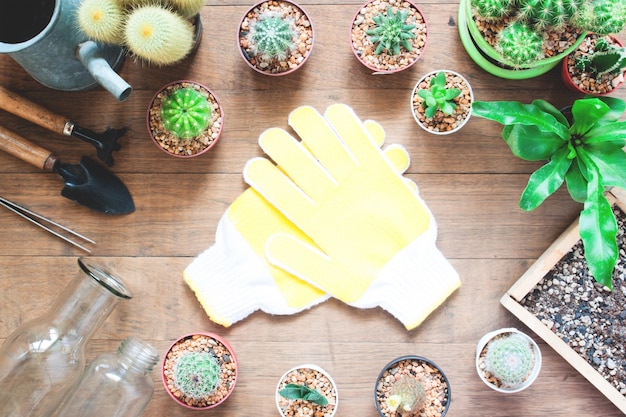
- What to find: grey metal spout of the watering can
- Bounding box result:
[76,41,133,101]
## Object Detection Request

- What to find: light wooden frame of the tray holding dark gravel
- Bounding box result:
[500,188,626,414]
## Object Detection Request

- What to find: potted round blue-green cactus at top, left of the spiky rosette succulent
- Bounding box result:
[238,0,314,75]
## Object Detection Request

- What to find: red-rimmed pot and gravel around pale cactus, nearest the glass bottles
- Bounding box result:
[161,332,239,410]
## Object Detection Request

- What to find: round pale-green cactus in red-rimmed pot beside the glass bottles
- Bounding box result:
[174,352,220,400]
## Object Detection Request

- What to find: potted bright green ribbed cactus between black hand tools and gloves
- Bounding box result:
[146,80,224,158]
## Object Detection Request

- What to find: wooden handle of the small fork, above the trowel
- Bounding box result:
[0,87,67,134]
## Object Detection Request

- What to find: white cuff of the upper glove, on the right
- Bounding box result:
[353,227,461,330]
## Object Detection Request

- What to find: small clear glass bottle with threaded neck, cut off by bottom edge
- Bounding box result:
[56,336,159,417]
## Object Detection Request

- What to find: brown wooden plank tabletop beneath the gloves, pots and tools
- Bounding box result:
[0,0,626,417]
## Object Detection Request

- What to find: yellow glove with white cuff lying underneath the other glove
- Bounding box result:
[183,121,409,327]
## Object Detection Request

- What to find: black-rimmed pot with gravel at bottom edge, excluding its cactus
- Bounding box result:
[374,355,452,417]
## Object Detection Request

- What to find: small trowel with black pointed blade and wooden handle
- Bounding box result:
[0,122,135,214]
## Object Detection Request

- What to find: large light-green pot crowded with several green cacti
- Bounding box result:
[459,0,626,79]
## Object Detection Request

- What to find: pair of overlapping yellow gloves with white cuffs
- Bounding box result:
[184,104,460,329]
